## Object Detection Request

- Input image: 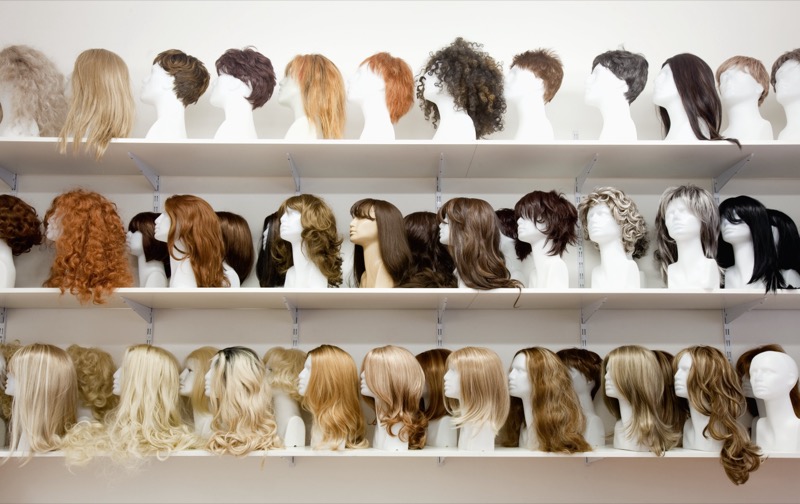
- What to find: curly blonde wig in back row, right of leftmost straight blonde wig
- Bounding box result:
[67,345,119,421]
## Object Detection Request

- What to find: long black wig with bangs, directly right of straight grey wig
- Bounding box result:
[717,196,783,291]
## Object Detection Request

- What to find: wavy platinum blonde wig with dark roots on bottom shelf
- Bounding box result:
[206,347,283,457]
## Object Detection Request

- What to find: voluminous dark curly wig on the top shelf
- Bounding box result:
[417,37,506,138]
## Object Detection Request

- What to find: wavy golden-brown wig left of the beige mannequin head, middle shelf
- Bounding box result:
[272,194,342,287]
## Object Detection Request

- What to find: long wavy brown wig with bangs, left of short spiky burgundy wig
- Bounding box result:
[437,198,521,290]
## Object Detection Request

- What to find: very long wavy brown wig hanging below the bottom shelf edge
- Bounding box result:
[673,345,761,485]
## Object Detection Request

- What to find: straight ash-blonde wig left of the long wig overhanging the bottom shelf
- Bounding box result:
[601,345,681,456]
